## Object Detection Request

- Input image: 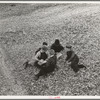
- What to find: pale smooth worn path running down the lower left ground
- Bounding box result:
[0,45,27,95]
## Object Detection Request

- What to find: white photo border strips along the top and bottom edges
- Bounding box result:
[0,1,100,100]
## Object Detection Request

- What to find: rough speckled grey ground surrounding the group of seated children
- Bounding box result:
[0,3,100,96]
